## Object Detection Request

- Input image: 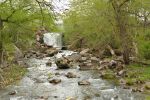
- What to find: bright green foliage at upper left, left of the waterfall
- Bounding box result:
[0,0,56,48]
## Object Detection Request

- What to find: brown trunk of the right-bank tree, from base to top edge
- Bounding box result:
[111,0,132,64]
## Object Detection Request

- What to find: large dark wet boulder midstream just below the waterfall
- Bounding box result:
[56,58,71,69]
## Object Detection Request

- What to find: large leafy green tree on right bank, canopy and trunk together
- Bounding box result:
[64,0,150,64]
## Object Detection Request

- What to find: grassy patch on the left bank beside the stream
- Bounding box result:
[0,65,27,88]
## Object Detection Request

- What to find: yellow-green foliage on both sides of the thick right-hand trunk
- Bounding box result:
[64,0,150,59]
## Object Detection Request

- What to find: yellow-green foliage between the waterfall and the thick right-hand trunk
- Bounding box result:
[64,0,116,46]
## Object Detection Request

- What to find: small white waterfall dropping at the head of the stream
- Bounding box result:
[43,33,62,49]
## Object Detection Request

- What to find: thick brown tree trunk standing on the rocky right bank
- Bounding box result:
[112,2,131,65]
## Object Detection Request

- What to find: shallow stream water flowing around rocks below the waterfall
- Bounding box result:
[0,33,145,100]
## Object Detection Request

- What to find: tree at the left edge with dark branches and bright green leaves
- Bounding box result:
[0,0,54,64]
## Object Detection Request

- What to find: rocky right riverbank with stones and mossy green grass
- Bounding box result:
[70,49,150,100]
